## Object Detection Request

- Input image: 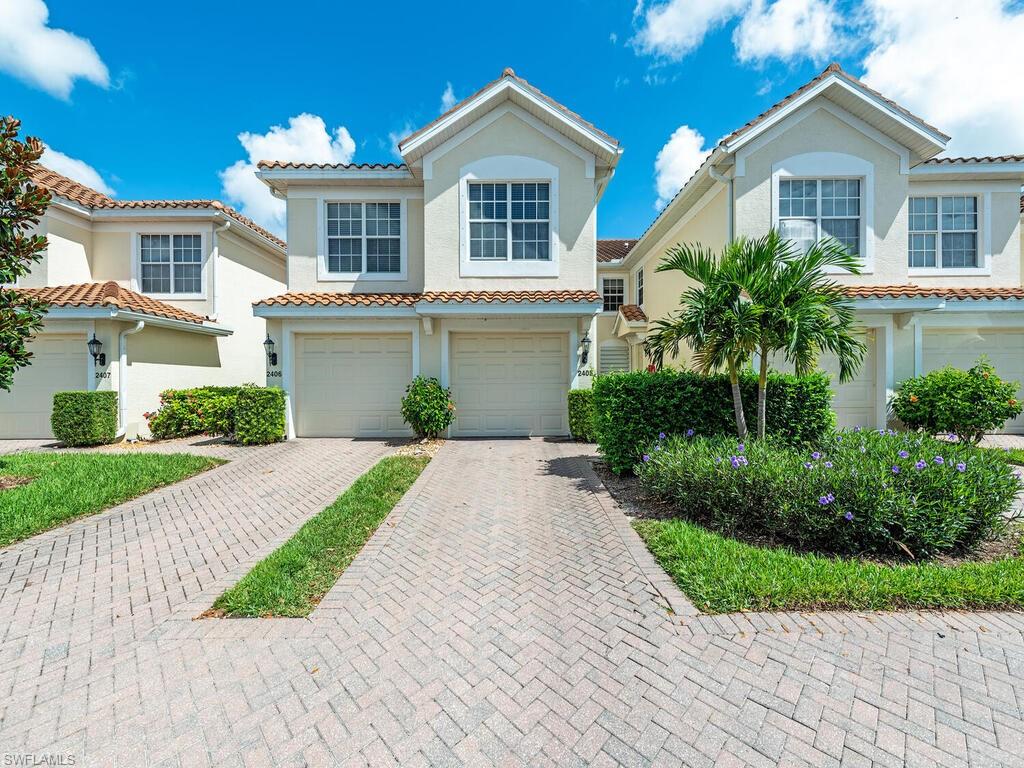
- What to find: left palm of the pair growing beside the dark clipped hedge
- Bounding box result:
[644,241,760,439]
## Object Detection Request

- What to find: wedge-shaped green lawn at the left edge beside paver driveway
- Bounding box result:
[0,453,223,547]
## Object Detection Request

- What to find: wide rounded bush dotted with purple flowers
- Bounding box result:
[636,431,1024,558]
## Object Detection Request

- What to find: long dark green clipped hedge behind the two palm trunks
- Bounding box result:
[592,369,836,473]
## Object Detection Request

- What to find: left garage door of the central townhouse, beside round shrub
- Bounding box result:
[295,334,413,437]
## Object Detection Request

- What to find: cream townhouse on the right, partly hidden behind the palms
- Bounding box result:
[598,63,1024,432]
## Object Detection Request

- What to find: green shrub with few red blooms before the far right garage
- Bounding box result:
[892,357,1021,443]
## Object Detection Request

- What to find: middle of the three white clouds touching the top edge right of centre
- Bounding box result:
[732,0,842,62]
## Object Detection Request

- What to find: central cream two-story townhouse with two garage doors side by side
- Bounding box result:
[254,70,621,436]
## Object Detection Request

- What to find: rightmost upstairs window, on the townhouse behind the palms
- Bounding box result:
[907,195,980,269]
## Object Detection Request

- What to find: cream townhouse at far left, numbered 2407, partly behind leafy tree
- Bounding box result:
[0,171,285,438]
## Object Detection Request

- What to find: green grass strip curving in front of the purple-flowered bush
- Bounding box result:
[633,520,1024,613]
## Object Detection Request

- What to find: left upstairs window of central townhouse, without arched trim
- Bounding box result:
[324,201,402,275]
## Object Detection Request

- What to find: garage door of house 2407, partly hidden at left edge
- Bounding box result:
[0,334,88,438]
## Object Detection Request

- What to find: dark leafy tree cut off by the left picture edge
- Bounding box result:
[0,117,50,391]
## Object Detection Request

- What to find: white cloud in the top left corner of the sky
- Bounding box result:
[0,0,111,99]
